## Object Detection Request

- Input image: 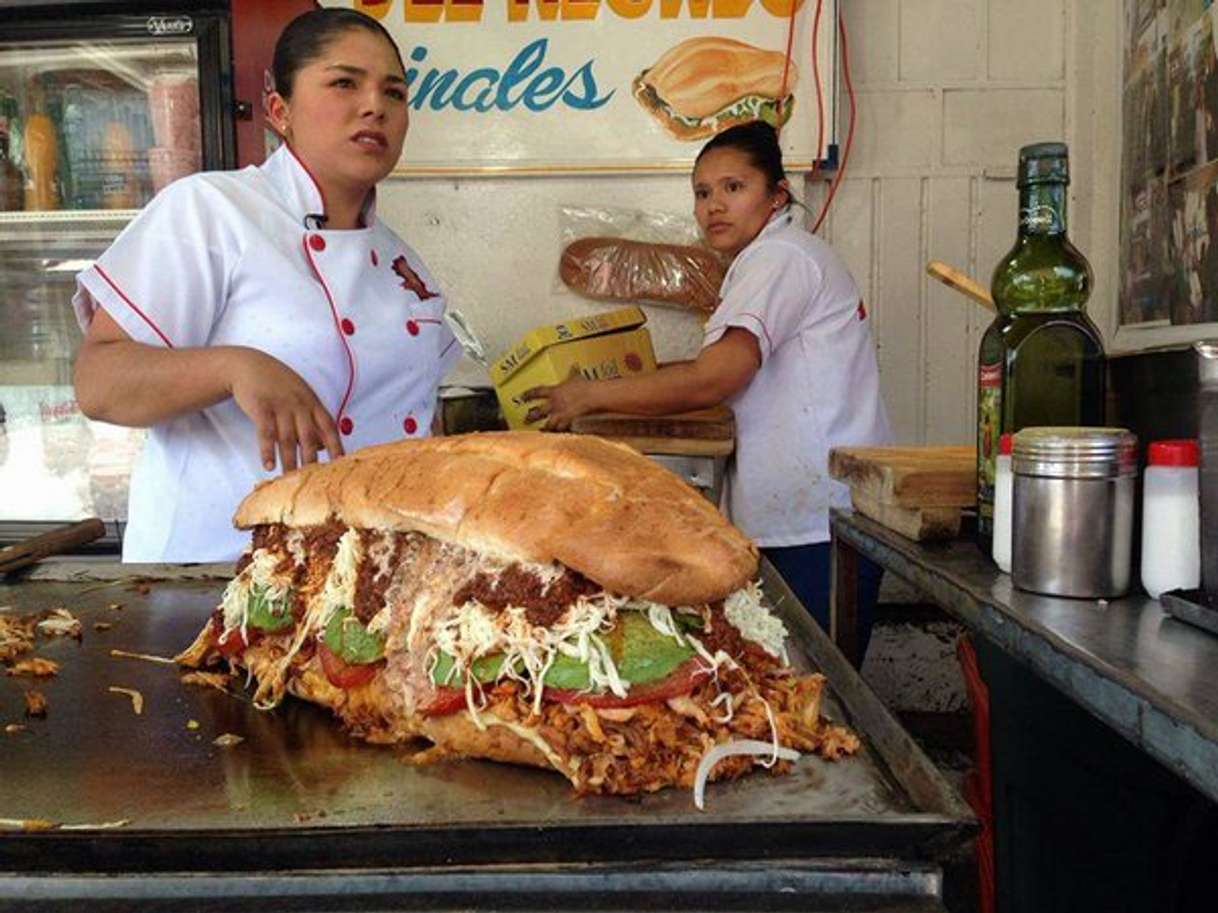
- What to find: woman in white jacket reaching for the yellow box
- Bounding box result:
[525,122,889,655]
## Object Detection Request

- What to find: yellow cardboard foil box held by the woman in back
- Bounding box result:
[491,307,655,429]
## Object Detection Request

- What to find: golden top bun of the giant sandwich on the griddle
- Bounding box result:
[233,431,758,605]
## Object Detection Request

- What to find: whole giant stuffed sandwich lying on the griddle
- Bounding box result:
[178,431,859,801]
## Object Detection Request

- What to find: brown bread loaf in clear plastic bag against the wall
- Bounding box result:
[558,236,725,314]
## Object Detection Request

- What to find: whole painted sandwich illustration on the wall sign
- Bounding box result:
[633,35,798,141]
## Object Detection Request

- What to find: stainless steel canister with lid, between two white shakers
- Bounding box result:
[1011,427,1138,599]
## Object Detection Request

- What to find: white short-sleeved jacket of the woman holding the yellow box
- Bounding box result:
[704,209,890,548]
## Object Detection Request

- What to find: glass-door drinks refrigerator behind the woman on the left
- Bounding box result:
[0,2,235,547]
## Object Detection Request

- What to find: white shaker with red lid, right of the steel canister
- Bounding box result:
[1141,441,1201,599]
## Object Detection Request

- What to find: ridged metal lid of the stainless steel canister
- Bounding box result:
[1011,427,1138,478]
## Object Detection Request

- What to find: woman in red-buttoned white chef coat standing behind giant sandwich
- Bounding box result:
[73,10,459,561]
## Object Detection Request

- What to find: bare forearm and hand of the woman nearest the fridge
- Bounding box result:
[73,308,342,471]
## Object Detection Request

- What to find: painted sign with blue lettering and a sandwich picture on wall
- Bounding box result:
[323,0,837,174]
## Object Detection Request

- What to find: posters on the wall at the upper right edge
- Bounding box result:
[1119,0,1218,343]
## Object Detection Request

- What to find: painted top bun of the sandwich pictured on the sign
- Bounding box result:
[639,35,795,118]
